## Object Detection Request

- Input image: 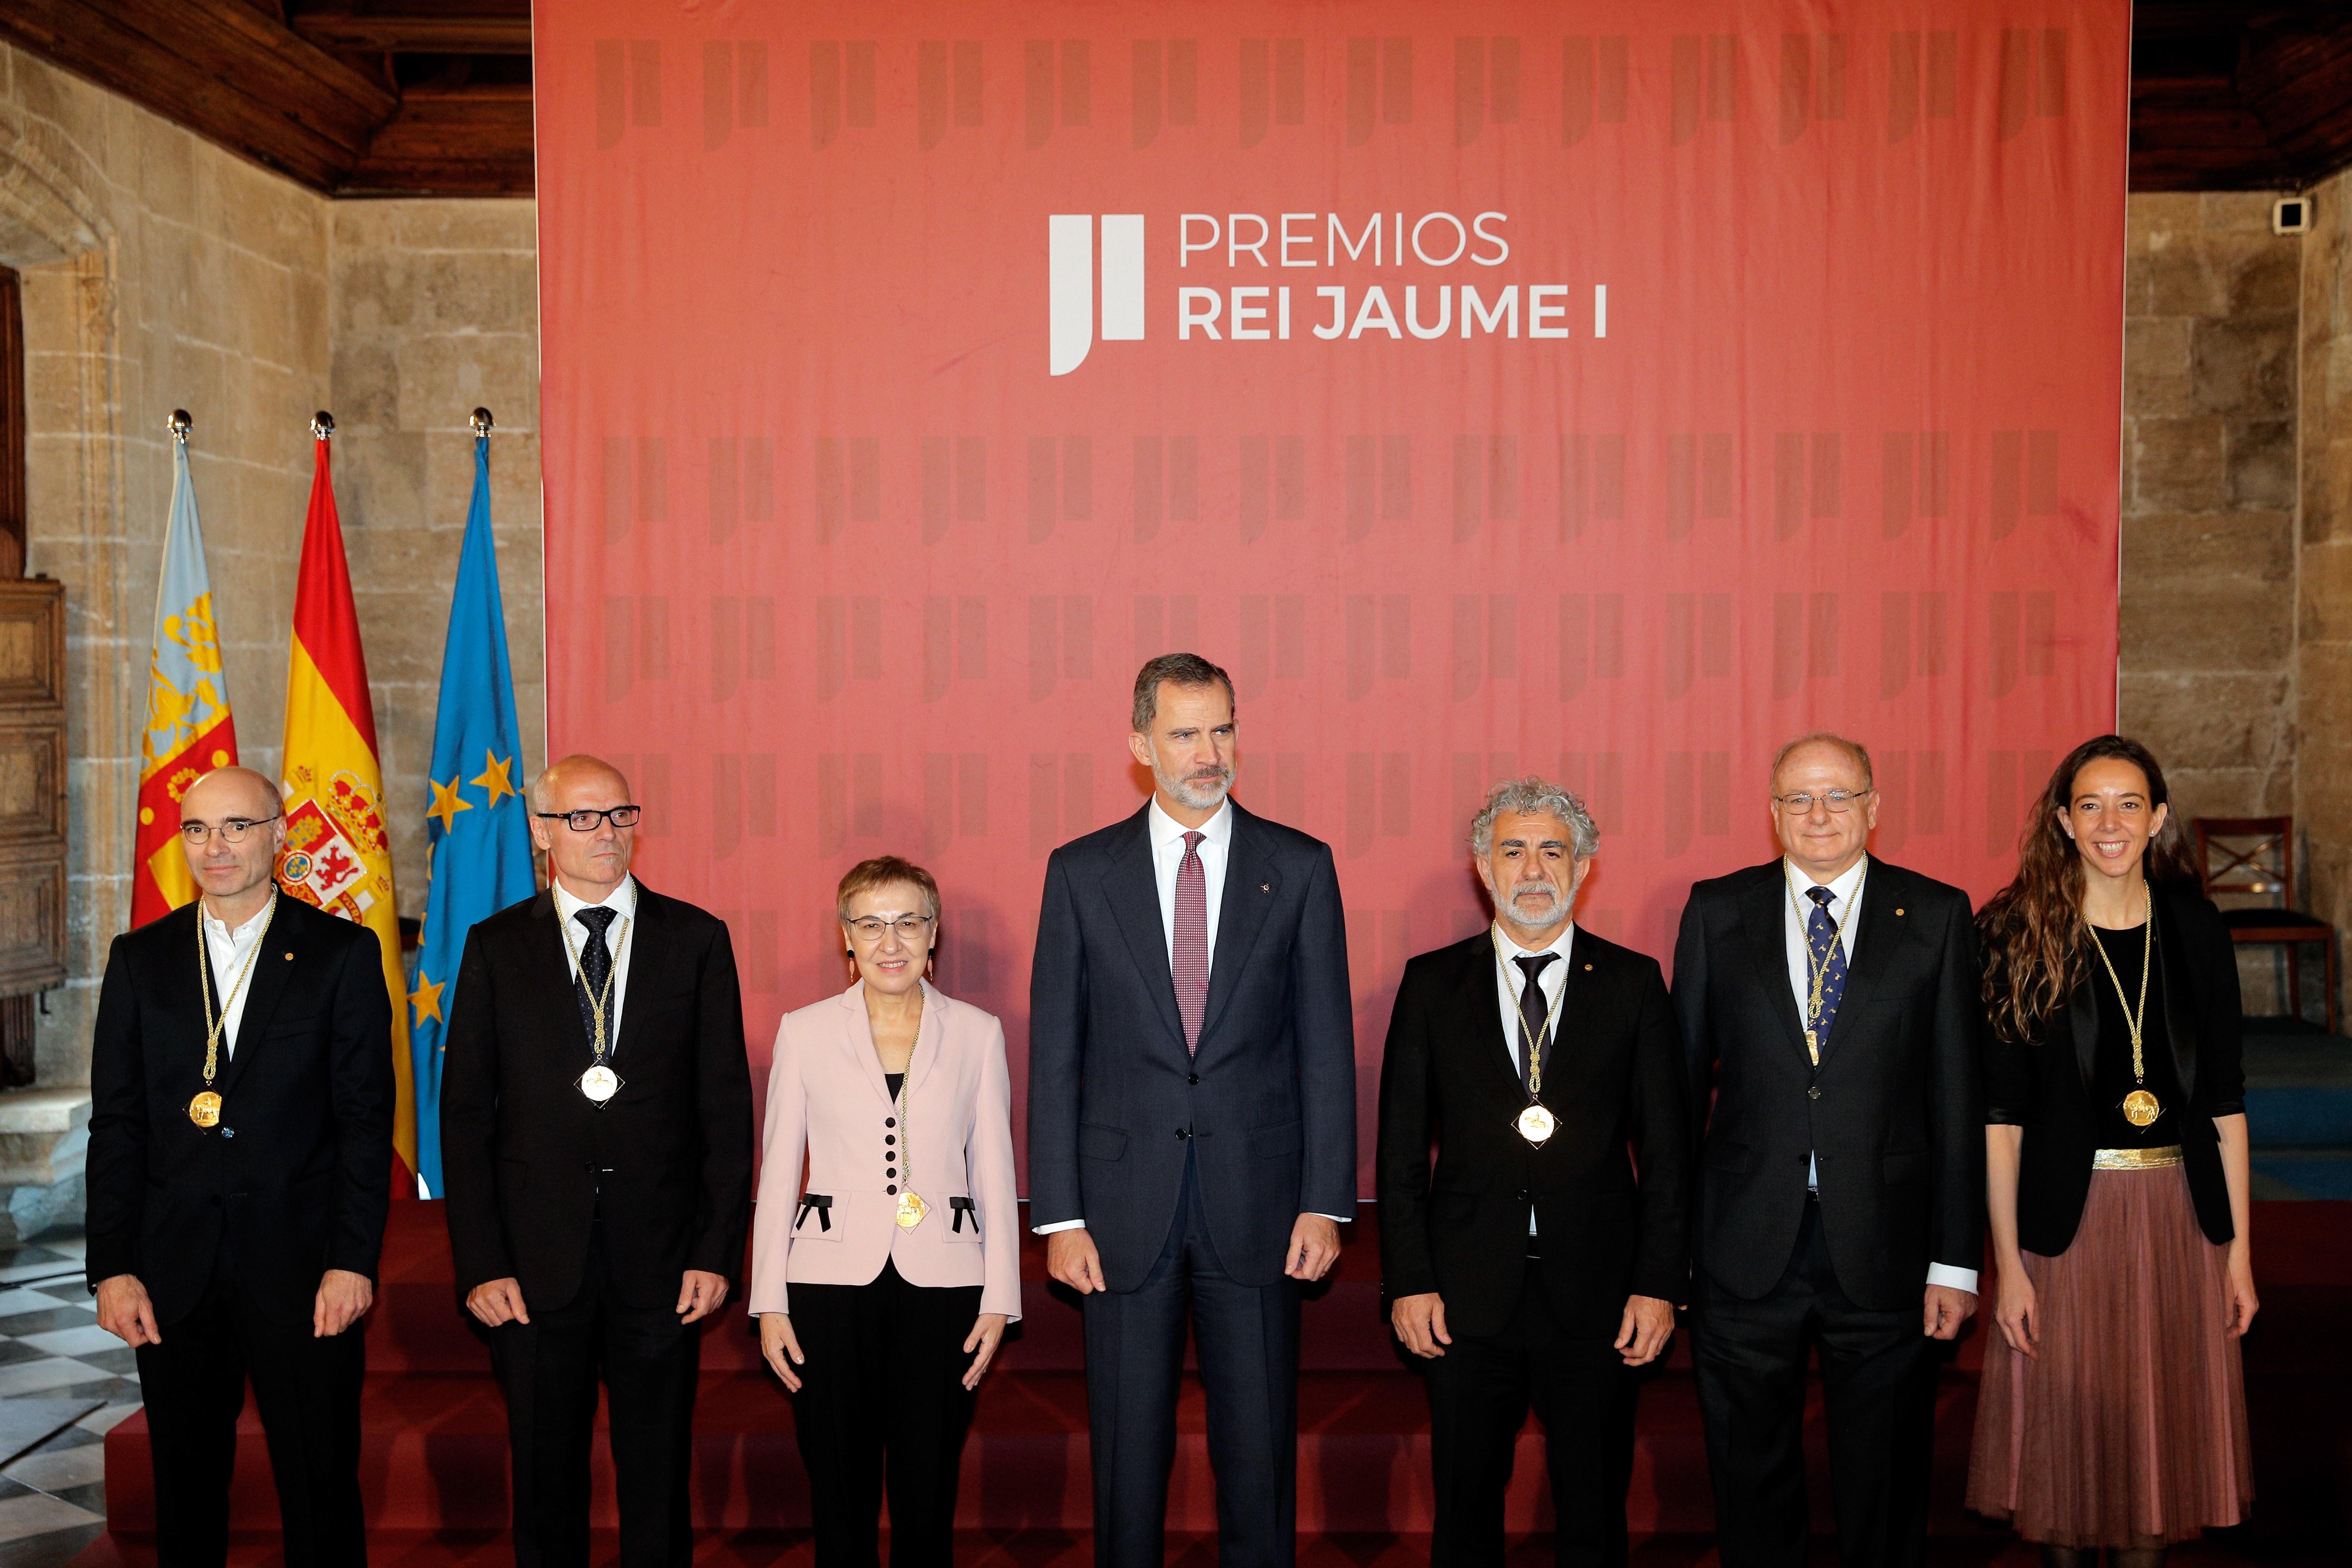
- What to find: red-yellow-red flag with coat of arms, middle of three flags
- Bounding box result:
[278,426,416,1192]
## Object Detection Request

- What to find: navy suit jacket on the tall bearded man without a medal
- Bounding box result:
[1028,802,1355,1291]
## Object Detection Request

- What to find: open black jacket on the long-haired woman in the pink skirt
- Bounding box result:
[1994,888,2246,1258]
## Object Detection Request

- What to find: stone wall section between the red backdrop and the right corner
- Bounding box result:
[2119,193,2303,816]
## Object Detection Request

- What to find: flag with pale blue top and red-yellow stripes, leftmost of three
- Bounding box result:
[132,421,238,926]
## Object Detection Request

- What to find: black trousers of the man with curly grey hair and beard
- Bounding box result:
[1421,1262,1637,1568]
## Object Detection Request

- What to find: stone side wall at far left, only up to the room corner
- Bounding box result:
[0,47,329,1084]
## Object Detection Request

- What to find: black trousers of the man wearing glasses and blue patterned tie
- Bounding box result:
[1691,1204,1940,1568]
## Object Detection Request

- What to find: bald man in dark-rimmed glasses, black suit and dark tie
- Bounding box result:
[442,757,750,1568]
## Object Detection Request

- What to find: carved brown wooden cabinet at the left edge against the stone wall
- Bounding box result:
[0,578,66,1088]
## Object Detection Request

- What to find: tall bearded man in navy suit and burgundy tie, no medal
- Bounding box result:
[1028,653,1355,1568]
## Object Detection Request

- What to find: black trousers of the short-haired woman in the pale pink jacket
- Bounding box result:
[793,1262,981,1568]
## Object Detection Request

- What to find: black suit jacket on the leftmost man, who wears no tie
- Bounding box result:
[87,896,395,1326]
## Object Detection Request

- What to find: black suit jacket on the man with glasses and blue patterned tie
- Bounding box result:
[1675,858,1985,1312]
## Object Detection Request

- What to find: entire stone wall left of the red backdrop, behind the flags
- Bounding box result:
[0,47,546,1084]
